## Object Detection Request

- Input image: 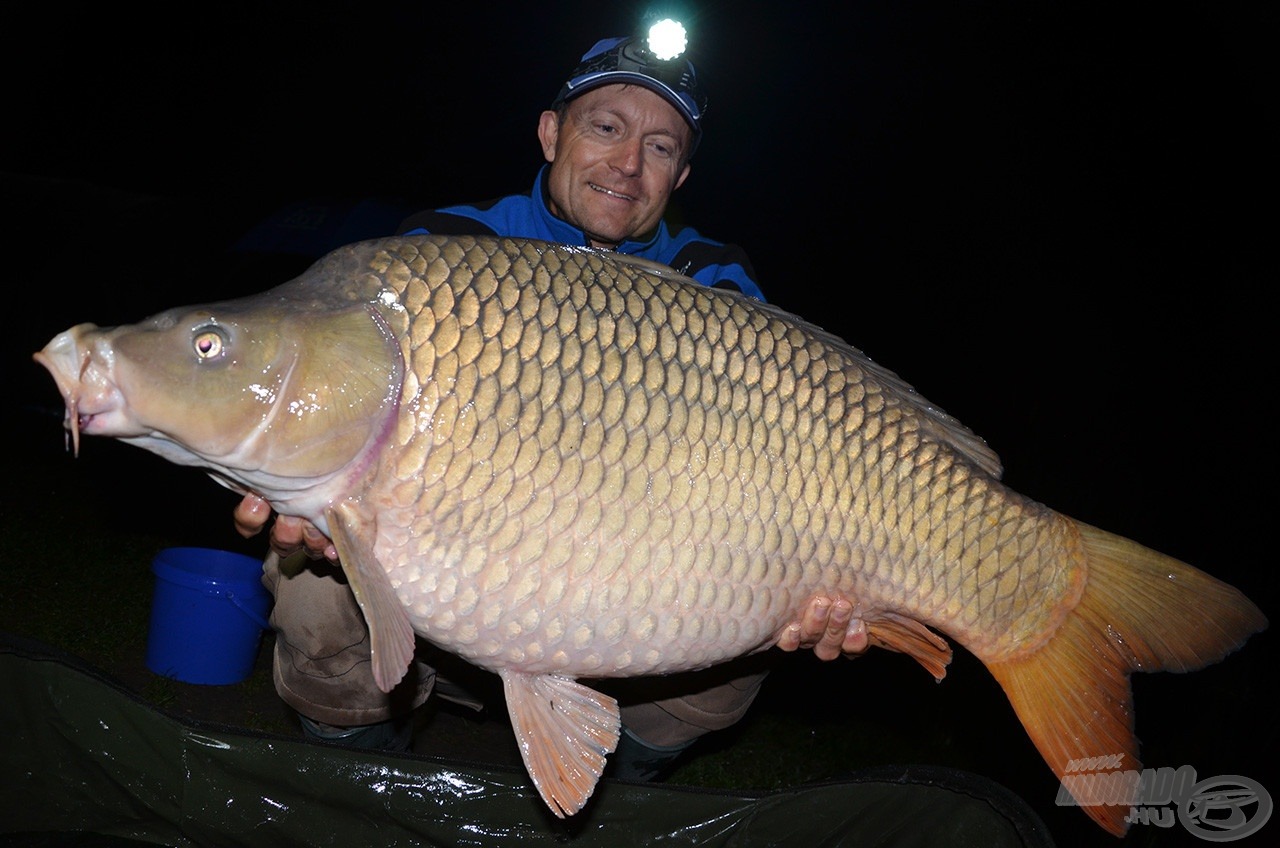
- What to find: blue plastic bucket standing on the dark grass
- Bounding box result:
[146,548,271,685]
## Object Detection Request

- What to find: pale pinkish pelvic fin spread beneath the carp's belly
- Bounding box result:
[499,671,621,819]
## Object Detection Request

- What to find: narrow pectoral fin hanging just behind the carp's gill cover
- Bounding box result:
[326,503,413,692]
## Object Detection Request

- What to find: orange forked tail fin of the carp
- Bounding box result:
[988,521,1267,836]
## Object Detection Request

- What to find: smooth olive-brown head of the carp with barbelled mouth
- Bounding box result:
[35,291,403,514]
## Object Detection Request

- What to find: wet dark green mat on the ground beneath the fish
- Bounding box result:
[0,638,1051,848]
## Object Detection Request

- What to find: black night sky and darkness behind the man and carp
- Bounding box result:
[0,0,1280,845]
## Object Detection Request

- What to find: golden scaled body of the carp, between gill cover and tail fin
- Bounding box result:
[348,240,1068,676]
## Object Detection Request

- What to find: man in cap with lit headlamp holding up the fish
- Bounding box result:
[236,31,867,779]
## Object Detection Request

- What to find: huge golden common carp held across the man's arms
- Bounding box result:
[36,236,1267,834]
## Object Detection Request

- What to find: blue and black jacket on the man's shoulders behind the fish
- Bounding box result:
[398,165,764,301]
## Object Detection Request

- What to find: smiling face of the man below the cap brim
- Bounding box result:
[538,85,692,247]
